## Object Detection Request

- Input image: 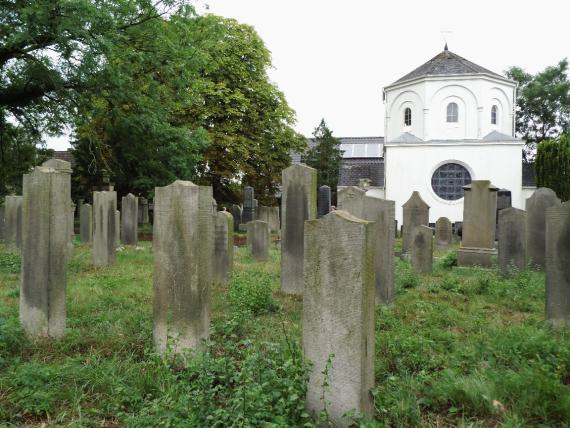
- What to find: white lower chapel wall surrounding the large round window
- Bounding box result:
[385,142,524,224]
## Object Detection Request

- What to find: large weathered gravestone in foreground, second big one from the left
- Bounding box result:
[153,180,214,353]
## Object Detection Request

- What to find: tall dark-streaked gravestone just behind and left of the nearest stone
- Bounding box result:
[281,164,317,295]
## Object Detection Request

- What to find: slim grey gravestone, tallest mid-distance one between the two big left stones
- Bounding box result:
[93,191,119,266]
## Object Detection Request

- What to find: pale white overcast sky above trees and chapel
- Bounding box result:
[48,0,570,150]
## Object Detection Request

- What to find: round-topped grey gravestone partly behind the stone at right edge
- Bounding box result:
[526,187,560,268]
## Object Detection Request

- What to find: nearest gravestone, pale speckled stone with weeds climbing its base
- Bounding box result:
[303,211,375,427]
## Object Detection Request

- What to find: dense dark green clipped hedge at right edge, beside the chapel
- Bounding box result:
[536,135,570,201]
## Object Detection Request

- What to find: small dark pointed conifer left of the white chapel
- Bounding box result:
[303,119,343,191]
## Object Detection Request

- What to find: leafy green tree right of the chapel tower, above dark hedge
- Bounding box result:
[507,59,570,154]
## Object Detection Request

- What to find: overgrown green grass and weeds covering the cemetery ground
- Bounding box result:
[0,242,570,427]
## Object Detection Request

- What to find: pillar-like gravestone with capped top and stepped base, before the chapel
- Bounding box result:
[457,180,498,267]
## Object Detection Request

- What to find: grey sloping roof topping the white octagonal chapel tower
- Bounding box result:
[392,44,508,85]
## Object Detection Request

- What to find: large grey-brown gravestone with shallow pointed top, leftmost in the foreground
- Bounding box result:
[20,166,71,338]
